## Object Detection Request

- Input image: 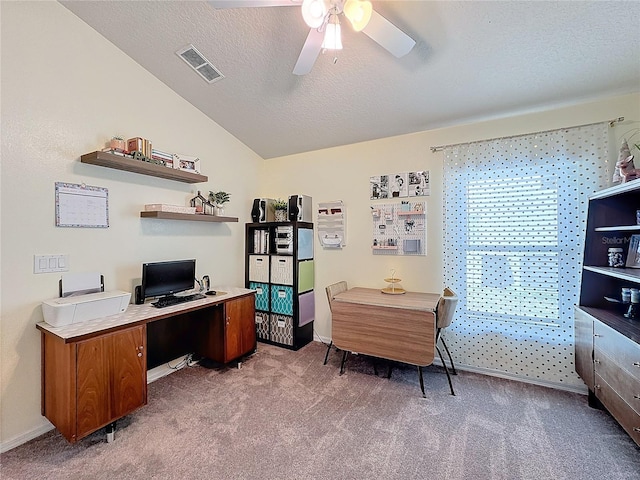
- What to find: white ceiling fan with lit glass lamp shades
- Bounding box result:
[209,0,416,75]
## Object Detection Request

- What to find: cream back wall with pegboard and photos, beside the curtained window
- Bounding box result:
[261,94,640,340]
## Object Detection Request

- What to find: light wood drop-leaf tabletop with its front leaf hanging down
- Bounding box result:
[331,287,440,366]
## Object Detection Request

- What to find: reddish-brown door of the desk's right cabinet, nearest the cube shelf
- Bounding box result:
[224,296,256,362]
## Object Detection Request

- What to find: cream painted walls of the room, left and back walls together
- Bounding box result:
[0,2,640,454]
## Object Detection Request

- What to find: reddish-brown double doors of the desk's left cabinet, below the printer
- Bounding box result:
[77,326,147,439]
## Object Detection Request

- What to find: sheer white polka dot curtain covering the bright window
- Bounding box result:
[443,123,608,386]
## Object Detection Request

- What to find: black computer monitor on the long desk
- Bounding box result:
[142,259,196,299]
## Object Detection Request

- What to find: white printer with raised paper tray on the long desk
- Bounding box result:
[42,273,131,327]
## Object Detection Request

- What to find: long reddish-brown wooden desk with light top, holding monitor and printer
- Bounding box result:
[36,287,256,443]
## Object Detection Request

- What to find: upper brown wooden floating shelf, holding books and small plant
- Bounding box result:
[80,151,209,183]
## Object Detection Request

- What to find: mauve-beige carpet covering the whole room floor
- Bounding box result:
[0,343,640,480]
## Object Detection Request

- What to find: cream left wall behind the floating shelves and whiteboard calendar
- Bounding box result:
[0,2,262,446]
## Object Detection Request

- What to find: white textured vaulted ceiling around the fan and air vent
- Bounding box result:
[61,0,640,158]
